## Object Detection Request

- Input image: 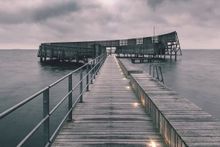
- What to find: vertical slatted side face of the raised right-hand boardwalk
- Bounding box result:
[130,76,188,147]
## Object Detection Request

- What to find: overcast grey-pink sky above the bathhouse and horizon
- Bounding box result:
[0,0,220,49]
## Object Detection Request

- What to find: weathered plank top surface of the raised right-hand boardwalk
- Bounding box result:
[121,59,220,147]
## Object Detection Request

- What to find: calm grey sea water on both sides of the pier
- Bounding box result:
[0,50,220,147]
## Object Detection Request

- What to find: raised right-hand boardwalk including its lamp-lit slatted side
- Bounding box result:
[120,60,220,147]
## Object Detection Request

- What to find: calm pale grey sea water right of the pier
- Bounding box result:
[135,50,220,119]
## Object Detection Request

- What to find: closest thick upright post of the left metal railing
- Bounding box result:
[43,87,50,145]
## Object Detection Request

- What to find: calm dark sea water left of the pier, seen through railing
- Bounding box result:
[0,50,84,147]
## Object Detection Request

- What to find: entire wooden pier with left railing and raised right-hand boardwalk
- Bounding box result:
[0,54,220,147]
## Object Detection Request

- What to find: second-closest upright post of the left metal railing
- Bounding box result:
[68,74,73,121]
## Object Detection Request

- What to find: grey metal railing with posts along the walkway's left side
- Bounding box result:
[0,54,106,147]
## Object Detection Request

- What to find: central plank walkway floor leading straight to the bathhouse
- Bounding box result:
[52,56,165,147]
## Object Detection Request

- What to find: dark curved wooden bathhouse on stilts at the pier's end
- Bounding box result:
[38,31,182,61]
